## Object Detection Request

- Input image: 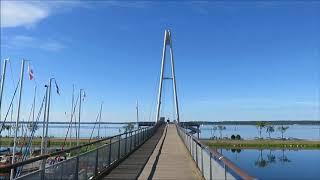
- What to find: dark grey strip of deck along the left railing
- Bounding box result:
[102,125,165,180]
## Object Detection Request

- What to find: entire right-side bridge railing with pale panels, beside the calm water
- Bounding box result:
[177,125,255,180]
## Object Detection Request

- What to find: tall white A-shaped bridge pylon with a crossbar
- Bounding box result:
[156,30,180,123]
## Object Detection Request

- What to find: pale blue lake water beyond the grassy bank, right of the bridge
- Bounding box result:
[200,125,320,140]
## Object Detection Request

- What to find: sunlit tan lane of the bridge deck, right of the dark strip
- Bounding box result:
[138,124,203,180]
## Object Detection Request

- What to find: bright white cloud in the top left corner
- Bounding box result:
[1,1,49,28]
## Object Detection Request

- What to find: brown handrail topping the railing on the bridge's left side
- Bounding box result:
[1,127,149,171]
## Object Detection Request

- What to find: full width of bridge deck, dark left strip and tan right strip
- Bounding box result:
[104,124,203,180]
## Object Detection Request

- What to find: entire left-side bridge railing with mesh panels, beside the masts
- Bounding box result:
[2,124,159,180]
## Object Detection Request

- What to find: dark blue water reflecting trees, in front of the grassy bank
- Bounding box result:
[219,149,320,179]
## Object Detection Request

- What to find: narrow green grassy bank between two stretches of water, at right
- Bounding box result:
[201,140,320,149]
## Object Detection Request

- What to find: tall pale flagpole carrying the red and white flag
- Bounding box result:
[10,59,25,180]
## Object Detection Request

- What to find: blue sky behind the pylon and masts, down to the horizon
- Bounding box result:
[1,1,320,121]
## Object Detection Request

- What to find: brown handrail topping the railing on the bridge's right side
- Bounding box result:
[177,125,256,180]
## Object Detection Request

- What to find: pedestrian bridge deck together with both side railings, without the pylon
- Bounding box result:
[5,123,254,180]
